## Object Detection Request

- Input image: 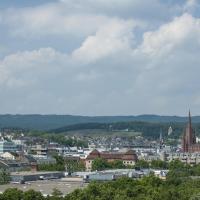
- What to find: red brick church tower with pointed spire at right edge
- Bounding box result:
[182,111,199,152]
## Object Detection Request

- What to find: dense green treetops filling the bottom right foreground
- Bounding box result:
[65,175,200,200]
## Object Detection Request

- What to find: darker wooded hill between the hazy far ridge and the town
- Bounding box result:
[51,121,200,139]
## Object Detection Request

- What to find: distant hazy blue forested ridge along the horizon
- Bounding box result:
[0,115,200,130]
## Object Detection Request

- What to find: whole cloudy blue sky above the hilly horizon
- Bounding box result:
[0,0,200,116]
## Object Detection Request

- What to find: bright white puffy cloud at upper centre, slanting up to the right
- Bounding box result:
[73,19,136,63]
